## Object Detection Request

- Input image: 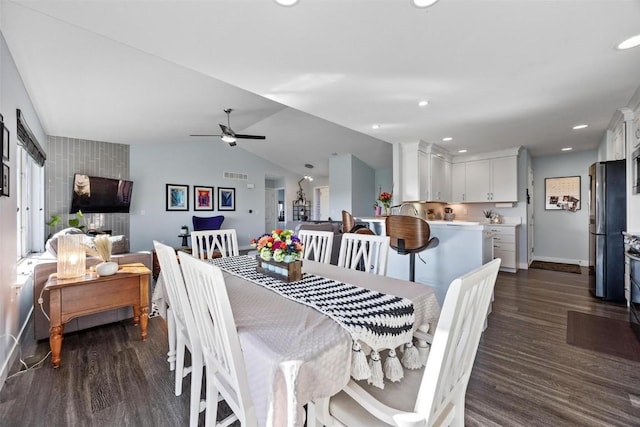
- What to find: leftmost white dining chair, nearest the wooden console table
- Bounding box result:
[153,240,204,427]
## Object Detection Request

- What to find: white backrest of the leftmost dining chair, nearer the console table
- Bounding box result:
[153,244,202,352]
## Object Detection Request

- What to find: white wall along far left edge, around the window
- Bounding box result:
[0,30,47,385]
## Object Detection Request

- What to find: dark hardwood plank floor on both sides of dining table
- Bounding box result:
[0,270,640,426]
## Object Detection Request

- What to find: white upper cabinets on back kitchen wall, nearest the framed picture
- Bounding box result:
[451,148,519,202]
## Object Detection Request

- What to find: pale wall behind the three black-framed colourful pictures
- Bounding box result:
[130,141,300,251]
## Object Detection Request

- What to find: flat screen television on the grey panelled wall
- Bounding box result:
[69,173,133,213]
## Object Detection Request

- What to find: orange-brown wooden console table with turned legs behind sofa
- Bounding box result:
[44,264,151,368]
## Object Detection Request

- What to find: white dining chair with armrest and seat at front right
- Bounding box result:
[309,258,500,427]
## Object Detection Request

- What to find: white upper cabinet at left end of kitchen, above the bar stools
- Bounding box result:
[396,141,451,202]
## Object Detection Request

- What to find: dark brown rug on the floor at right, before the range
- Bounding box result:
[567,311,640,362]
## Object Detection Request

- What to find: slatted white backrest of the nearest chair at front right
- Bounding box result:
[414,258,501,425]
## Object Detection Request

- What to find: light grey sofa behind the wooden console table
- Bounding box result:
[33,251,153,340]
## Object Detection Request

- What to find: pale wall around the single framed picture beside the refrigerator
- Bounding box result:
[532,150,598,266]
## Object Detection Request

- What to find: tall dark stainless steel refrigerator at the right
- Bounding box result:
[589,160,627,301]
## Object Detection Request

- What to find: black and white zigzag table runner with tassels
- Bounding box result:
[210,255,423,388]
